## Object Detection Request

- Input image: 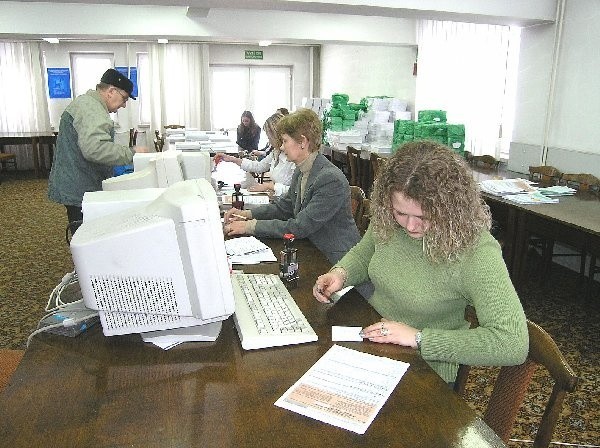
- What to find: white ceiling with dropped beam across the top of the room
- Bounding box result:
[0,0,556,45]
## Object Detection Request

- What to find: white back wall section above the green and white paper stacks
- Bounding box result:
[321,45,416,112]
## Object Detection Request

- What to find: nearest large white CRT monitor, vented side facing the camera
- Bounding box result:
[71,179,234,335]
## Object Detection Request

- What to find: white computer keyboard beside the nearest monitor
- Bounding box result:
[231,274,318,350]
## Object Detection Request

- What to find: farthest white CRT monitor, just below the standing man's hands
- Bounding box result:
[102,150,212,191]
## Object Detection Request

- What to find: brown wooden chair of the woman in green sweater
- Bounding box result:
[454,320,579,448]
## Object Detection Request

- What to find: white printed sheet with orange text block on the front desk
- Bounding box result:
[275,345,409,434]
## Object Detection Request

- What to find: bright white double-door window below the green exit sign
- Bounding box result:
[211,66,292,133]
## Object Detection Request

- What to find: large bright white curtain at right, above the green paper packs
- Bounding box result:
[415,20,520,158]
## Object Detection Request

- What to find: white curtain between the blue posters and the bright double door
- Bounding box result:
[148,44,210,136]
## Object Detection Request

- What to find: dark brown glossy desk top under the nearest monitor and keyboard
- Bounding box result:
[0,241,504,448]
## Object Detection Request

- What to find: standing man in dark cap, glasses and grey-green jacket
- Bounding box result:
[48,68,148,231]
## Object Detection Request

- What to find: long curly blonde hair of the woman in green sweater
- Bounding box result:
[371,141,491,262]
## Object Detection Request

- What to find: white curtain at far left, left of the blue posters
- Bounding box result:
[0,42,51,132]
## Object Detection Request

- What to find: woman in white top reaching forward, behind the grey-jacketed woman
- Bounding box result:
[215,113,296,196]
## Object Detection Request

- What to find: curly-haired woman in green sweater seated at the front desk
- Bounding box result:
[313,141,529,383]
